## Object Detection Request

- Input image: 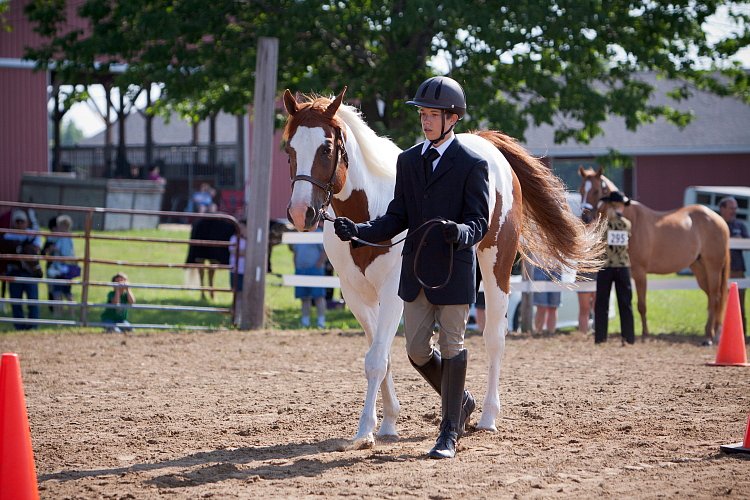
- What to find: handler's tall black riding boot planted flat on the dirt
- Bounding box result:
[429,350,466,458]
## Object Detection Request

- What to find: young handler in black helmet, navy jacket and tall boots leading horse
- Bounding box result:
[334,76,489,458]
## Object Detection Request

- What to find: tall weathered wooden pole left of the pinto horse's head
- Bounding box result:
[240,37,279,330]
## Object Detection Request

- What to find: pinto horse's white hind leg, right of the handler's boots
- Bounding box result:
[477,288,508,432]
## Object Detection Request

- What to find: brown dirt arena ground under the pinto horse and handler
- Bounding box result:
[5,331,750,499]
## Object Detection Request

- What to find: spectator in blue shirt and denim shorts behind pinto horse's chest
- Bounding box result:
[291,227,328,328]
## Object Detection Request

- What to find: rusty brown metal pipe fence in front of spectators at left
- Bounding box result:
[0,201,239,330]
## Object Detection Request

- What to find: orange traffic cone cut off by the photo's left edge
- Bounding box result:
[0,353,39,500]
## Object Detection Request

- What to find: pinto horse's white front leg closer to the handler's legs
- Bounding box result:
[372,290,404,436]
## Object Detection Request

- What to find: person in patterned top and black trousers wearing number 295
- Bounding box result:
[594,191,635,345]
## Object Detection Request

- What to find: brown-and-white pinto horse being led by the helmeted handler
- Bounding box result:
[284,88,601,448]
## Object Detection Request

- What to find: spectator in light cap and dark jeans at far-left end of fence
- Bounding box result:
[4,209,43,330]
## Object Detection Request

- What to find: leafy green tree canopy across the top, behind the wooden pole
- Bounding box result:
[26,0,750,146]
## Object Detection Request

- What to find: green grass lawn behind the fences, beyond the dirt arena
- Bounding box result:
[0,226,736,335]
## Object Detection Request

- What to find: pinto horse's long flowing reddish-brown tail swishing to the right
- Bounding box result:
[477,130,606,272]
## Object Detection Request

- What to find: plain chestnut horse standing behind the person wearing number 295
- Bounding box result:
[578,167,729,341]
